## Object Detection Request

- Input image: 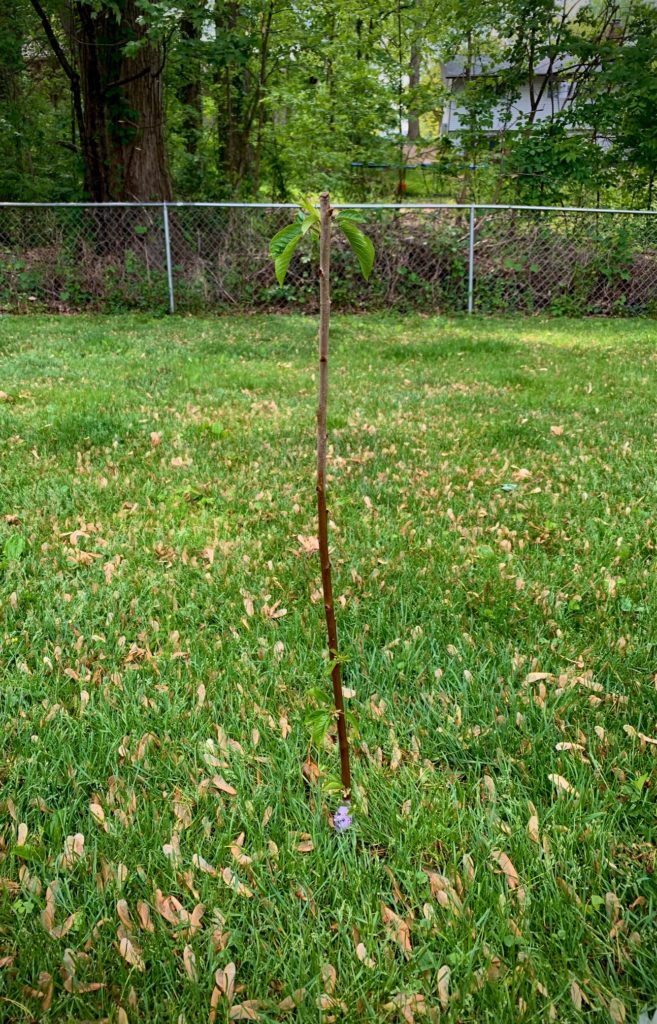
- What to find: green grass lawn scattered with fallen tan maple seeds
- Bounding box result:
[0,316,657,1024]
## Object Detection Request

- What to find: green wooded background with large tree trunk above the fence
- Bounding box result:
[0,0,657,208]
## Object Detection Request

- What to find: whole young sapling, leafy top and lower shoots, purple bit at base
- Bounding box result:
[269,193,375,815]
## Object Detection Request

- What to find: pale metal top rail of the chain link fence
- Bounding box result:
[0,201,657,217]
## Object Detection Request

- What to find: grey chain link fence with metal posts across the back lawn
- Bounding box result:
[0,203,657,315]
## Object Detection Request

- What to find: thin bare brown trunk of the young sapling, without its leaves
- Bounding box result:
[317,193,351,797]
